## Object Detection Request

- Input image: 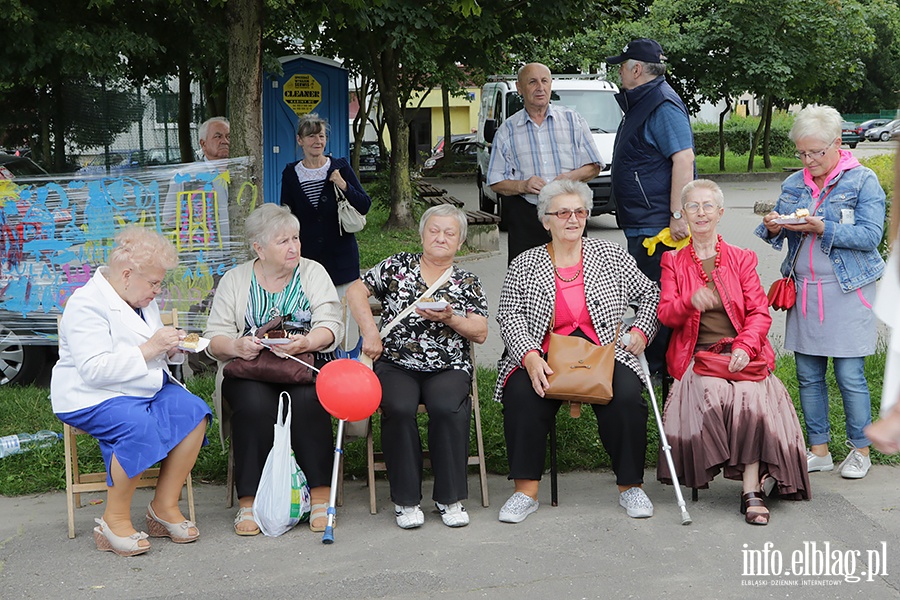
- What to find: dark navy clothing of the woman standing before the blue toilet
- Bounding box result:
[281,158,372,286]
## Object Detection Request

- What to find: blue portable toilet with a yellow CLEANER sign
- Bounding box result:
[262,54,350,203]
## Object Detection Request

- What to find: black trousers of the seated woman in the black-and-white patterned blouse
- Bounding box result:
[375,360,472,506]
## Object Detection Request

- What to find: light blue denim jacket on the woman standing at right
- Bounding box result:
[754,166,885,293]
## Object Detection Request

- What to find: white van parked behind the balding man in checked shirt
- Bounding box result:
[476,75,622,223]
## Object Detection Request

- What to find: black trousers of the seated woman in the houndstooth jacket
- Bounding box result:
[503,362,647,485]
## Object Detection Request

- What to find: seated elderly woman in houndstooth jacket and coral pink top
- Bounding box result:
[494,179,659,523]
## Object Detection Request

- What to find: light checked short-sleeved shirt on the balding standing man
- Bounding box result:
[487,104,604,204]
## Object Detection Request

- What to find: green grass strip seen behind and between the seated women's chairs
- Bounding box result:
[0,352,884,496]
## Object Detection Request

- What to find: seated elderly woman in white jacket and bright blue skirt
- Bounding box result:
[50,227,212,556]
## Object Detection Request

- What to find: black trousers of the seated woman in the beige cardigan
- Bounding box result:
[222,378,334,498]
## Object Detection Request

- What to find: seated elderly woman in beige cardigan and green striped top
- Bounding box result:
[204,204,343,535]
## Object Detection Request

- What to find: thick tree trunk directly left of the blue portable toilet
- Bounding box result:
[226,0,264,246]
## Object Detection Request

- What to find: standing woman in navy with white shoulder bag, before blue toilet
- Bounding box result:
[281,113,372,296]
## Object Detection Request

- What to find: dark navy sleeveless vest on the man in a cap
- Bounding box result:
[612,75,693,229]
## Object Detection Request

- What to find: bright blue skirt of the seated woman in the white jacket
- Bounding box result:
[56,382,212,487]
